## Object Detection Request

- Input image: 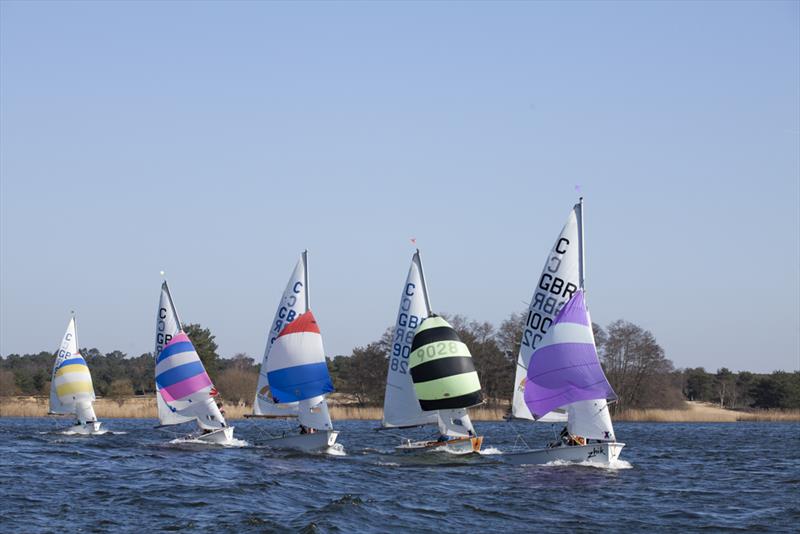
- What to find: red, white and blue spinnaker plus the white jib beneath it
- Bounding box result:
[266,310,333,430]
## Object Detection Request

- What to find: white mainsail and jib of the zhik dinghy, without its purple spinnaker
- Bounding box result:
[511,199,613,439]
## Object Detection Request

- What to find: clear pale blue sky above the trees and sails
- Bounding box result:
[0,1,800,371]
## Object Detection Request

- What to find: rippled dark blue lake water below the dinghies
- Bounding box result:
[0,418,800,534]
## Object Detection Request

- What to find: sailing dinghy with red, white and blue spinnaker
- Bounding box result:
[247,251,340,452]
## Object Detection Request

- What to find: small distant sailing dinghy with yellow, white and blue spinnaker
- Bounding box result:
[49,315,106,434]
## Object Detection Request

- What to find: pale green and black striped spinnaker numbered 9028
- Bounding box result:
[409,315,481,411]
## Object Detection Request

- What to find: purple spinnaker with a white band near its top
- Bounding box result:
[525,290,617,418]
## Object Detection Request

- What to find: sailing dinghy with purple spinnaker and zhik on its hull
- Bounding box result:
[502,199,625,465]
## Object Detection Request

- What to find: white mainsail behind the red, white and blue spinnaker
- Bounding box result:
[253,251,308,417]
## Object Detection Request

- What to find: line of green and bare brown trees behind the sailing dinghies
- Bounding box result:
[0,318,800,412]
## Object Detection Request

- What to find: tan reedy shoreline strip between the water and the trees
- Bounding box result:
[0,395,800,423]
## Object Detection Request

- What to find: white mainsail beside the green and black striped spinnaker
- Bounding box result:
[382,251,439,427]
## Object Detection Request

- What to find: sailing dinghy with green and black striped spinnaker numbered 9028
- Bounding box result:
[381,250,483,454]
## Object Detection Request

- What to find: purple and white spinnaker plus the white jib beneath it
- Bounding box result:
[525,289,616,440]
